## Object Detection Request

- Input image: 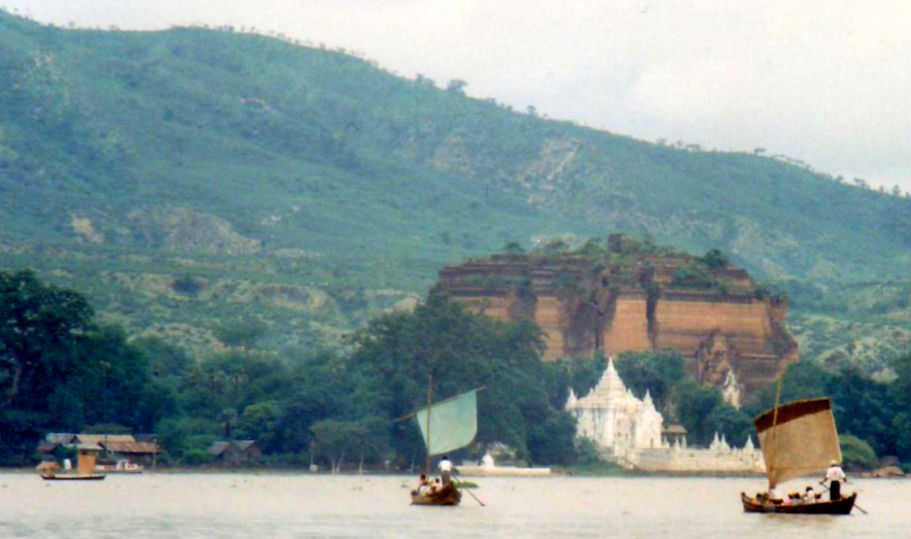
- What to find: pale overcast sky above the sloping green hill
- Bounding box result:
[7,0,911,191]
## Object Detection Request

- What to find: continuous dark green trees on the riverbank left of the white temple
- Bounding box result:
[0,271,600,469]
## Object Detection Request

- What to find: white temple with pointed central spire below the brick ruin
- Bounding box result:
[566,358,664,455]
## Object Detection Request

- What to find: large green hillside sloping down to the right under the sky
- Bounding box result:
[0,12,911,364]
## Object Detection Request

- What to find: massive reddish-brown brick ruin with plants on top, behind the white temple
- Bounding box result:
[434,236,797,394]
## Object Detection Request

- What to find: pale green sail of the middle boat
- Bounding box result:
[416,389,478,455]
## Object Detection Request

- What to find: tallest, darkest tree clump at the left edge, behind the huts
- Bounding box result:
[0,271,165,463]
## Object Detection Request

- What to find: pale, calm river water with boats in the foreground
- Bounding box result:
[0,473,911,539]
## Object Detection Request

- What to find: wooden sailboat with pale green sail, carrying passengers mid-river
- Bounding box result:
[411,377,483,506]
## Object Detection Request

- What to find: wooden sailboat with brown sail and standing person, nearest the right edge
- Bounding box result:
[740,398,857,515]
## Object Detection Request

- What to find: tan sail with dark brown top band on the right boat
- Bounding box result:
[755,398,841,489]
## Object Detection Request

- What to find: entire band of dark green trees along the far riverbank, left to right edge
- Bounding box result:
[0,271,911,469]
